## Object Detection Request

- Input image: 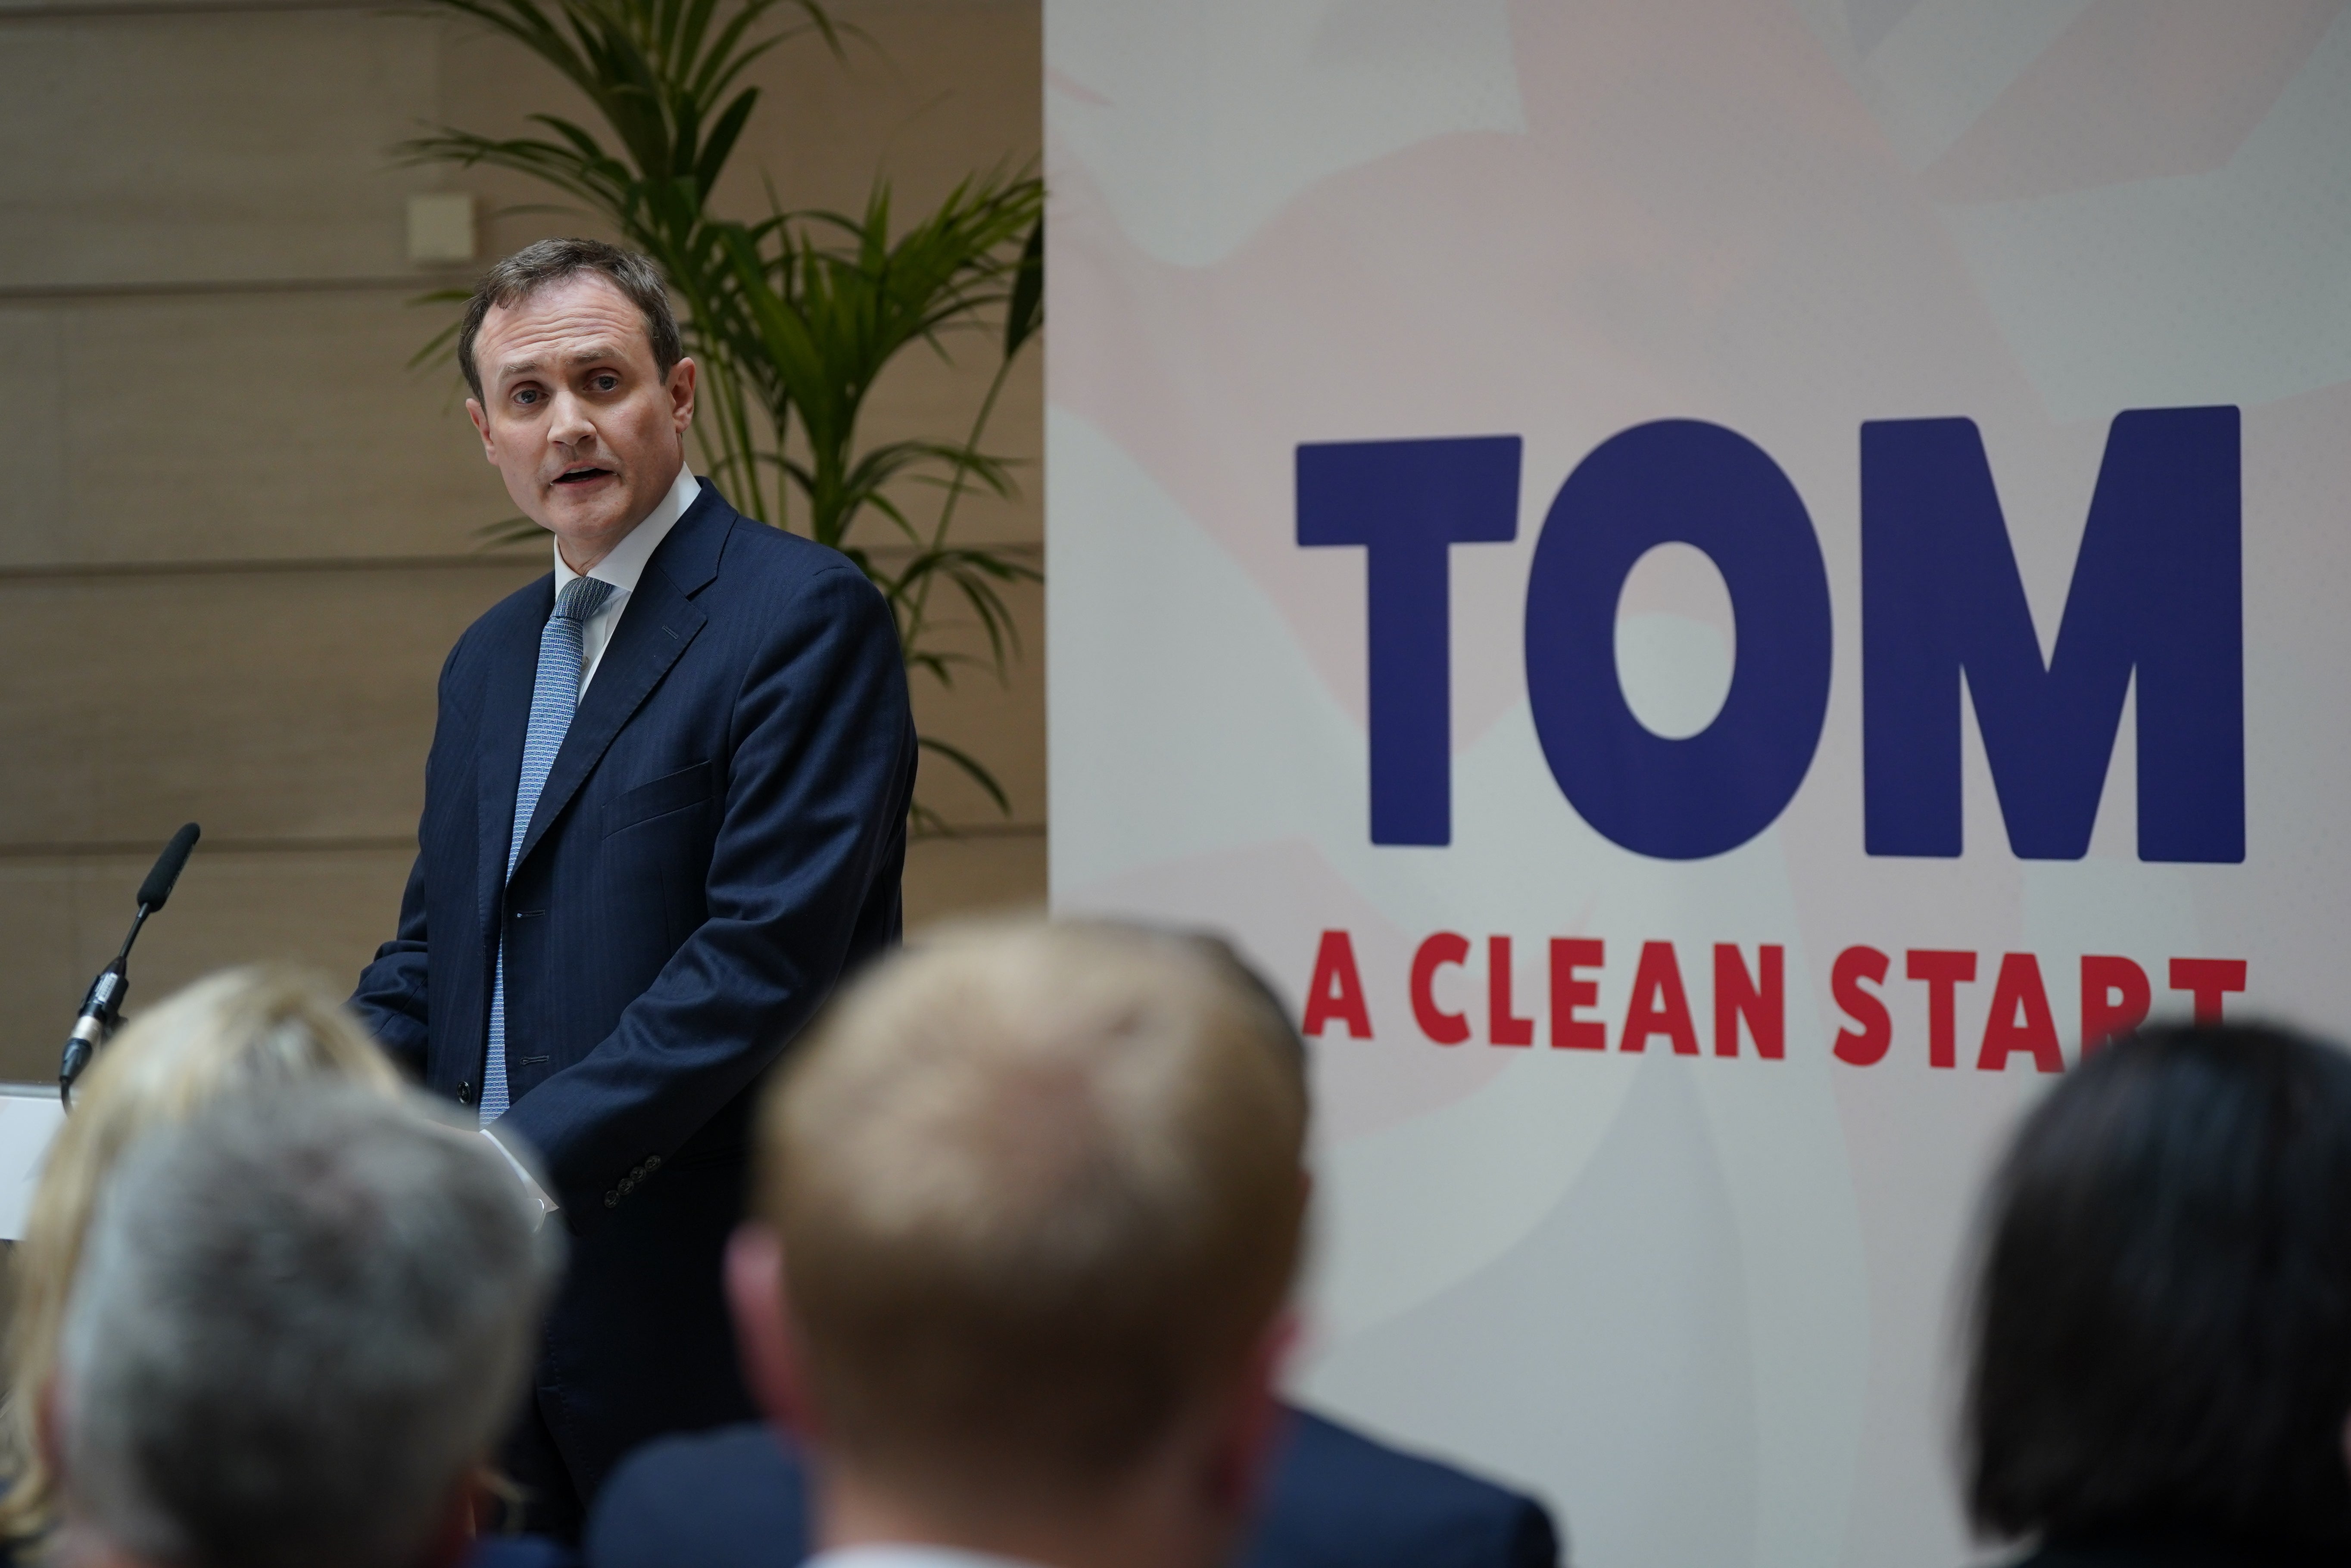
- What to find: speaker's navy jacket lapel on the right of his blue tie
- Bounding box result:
[501,496,733,870]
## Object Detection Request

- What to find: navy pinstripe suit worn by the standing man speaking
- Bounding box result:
[352,482,914,1497]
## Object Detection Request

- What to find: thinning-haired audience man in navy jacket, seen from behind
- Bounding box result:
[588,926,1559,1568]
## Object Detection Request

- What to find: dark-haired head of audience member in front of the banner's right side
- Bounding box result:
[1963,1027,2351,1568]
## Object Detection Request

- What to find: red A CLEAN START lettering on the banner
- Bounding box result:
[1303,931,2245,1072]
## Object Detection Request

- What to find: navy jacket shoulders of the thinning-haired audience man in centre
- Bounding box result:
[586,1410,1559,1568]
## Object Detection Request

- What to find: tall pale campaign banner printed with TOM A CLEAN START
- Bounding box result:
[1046,0,2351,1568]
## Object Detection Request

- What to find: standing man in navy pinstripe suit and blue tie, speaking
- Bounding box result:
[352,240,914,1535]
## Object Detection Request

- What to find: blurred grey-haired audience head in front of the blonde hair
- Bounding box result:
[45,1084,560,1568]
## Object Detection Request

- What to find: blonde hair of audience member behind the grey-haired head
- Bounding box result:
[0,966,400,1559]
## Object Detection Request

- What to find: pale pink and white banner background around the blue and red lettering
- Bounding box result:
[1046,0,2351,1568]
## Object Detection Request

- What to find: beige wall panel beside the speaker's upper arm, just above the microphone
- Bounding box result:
[0,562,543,846]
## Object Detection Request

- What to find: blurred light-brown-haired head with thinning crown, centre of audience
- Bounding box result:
[729,921,1307,1563]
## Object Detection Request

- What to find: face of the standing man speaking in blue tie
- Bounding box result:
[465,273,694,571]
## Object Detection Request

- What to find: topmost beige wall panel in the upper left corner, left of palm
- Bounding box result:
[0,9,437,287]
